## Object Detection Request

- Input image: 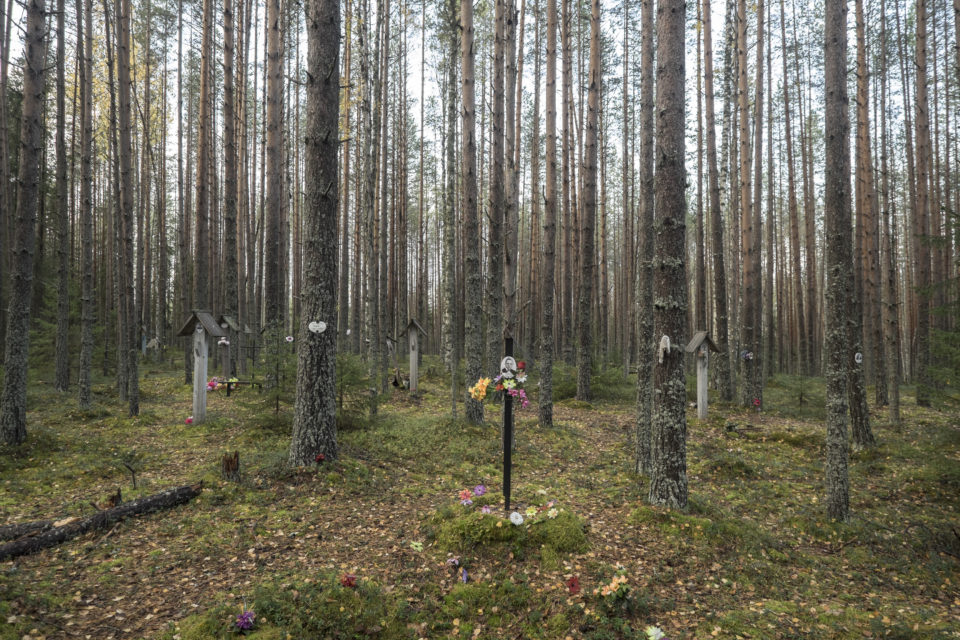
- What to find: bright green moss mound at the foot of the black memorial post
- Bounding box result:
[429,507,589,555]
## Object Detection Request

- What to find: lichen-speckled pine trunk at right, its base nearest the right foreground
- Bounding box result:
[824,0,853,521]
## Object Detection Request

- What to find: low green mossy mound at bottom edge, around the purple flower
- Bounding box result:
[170,575,410,640]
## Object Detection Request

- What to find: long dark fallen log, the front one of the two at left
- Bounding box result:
[0,483,203,561]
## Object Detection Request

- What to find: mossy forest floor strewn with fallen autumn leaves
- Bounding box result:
[0,358,960,640]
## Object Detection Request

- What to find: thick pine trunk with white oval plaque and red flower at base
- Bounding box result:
[286,0,340,467]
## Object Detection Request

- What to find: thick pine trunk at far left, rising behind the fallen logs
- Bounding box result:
[0,0,46,445]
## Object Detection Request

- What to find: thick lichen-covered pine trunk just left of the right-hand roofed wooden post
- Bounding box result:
[648,0,687,509]
